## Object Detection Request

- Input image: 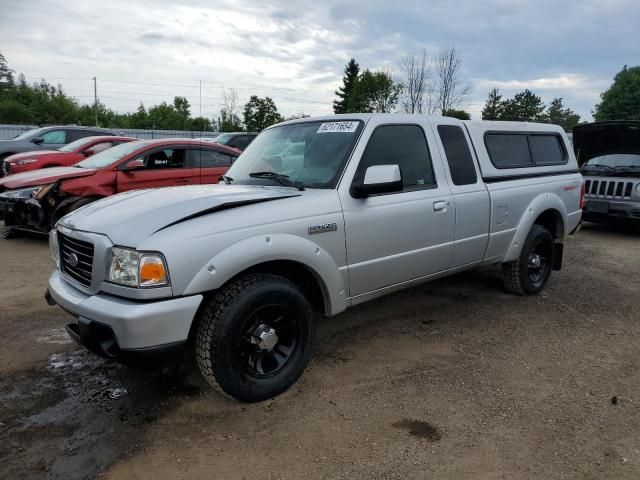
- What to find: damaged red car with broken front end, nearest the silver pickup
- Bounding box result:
[0,138,241,233]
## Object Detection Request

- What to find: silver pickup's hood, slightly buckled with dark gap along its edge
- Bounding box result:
[59,185,299,247]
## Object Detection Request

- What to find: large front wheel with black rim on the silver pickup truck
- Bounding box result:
[195,274,316,402]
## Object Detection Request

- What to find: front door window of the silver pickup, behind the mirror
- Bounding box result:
[354,125,436,191]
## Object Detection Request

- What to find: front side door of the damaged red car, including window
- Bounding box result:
[116,146,199,193]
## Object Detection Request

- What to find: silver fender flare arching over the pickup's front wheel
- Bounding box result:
[183,233,347,315]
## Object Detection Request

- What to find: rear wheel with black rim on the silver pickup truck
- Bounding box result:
[502,225,555,296]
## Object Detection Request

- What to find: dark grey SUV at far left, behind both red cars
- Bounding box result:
[0,126,115,175]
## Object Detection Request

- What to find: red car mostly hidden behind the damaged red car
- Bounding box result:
[2,136,136,175]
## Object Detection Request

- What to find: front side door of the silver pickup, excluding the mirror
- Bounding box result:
[339,122,455,303]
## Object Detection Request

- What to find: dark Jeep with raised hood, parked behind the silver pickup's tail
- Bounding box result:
[573,120,640,223]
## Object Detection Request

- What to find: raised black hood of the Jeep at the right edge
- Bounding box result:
[573,121,640,166]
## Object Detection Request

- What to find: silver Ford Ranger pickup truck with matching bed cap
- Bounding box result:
[46,114,583,401]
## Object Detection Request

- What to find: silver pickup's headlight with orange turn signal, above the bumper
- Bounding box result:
[109,247,169,287]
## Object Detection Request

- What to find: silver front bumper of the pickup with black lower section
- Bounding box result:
[46,270,202,358]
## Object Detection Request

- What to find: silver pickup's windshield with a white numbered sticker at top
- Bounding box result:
[227,120,362,188]
